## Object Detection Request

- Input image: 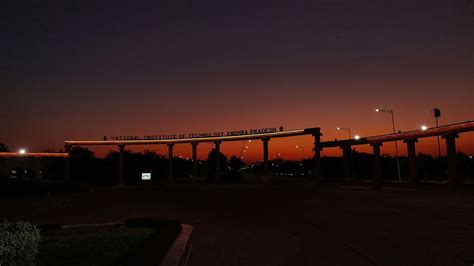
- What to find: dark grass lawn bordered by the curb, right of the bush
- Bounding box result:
[36,226,156,266]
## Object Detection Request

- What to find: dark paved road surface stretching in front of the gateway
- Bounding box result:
[0,181,474,266]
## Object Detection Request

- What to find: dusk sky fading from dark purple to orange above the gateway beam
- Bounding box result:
[0,0,474,160]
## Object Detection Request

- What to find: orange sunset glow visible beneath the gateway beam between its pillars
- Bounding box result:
[83,132,474,163]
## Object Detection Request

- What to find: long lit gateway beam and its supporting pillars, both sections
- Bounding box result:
[65,121,474,186]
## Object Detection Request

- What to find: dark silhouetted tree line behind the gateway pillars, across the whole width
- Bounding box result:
[0,144,474,185]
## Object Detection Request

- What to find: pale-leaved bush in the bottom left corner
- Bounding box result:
[0,220,40,266]
